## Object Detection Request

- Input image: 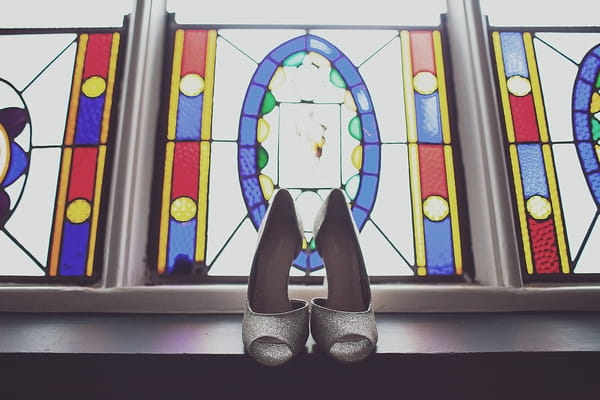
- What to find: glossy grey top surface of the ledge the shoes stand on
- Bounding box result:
[0,312,600,357]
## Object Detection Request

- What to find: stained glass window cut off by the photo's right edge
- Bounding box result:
[489,27,600,281]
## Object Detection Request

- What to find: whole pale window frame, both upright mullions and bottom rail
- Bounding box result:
[0,0,600,313]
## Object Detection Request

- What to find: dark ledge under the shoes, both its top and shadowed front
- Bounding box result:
[0,312,600,399]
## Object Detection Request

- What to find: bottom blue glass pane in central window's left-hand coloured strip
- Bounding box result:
[167,218,196,272]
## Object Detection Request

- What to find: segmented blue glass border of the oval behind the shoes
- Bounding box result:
[238,34,380,270]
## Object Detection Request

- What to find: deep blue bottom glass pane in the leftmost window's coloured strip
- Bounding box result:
[58,221,90,276]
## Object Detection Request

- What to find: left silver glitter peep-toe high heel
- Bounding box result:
[242,189,309,366]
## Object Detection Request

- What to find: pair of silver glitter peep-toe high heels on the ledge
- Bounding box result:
[242,189,377,366]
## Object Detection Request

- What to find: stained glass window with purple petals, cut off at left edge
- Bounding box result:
[0,26,126,282]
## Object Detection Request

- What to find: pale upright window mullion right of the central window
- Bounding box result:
[448,0,522,287]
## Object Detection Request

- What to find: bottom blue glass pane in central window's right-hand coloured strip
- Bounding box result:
[423,218,455,275]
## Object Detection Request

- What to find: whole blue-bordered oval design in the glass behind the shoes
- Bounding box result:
[238,34,381,270]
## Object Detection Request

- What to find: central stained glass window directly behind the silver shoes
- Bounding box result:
[151,15,465,279]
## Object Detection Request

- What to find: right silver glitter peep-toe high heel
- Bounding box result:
[310,189,377,362]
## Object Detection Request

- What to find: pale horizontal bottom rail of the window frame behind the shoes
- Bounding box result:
[0,284,600,314]
